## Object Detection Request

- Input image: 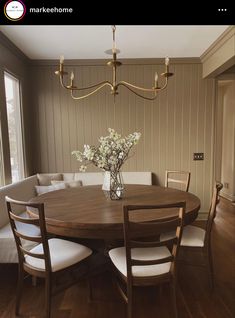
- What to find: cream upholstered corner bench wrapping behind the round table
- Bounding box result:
[0,172,152,263]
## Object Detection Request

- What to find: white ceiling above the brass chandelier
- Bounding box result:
[0,25,228,59]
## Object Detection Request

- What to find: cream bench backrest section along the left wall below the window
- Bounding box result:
[0,175,38,228]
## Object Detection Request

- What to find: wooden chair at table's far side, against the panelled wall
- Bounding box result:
[165,170,190,192]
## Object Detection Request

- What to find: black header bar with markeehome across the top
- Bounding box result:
[0,0,235,25]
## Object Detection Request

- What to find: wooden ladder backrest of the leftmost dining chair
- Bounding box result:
[5,197,51,276]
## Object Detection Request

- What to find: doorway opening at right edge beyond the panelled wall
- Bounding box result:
[215,74,235,202]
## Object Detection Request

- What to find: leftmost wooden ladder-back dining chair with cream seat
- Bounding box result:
[5,197,92,318]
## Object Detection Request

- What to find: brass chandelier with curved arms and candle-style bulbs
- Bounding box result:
[55,25,174,100]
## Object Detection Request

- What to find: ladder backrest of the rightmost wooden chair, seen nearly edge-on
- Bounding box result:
[205,181,223,246]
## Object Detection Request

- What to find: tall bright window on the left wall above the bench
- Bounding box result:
[4,72,24,182]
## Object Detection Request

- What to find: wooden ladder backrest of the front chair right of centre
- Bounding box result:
[123,202,185,285]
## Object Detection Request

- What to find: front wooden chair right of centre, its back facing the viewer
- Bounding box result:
[109,202,185,318]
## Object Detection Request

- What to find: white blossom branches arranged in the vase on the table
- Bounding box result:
[72,128,141,172]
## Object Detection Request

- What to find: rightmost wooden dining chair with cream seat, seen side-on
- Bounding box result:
[160,182,223,289]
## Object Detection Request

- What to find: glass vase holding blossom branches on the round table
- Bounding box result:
[102,171,124,200]
